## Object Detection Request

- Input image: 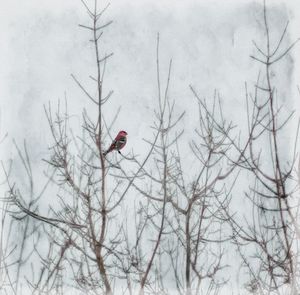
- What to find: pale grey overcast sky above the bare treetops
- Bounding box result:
[0,0,300,162]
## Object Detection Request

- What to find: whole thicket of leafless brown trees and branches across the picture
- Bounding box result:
[0,0,300,295]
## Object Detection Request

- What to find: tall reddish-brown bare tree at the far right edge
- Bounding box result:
[192,3,300,294]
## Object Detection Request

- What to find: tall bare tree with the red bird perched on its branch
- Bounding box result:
[2,0,170,294]
